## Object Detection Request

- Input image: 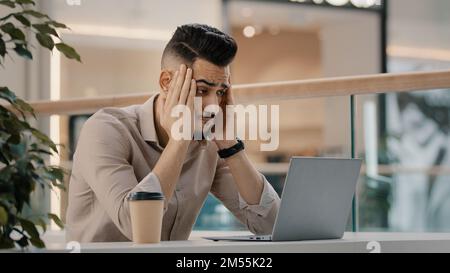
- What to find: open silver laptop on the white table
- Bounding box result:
[203,157,361,241]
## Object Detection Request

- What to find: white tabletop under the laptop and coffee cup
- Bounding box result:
[46,231,450,253]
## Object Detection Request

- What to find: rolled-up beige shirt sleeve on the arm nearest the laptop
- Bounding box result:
[211,159,280,235]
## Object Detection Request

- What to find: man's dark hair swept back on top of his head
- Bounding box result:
[162,24,237,67]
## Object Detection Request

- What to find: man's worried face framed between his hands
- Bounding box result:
[192,59,230,123]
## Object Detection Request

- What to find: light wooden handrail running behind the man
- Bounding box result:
[23,70,450,115]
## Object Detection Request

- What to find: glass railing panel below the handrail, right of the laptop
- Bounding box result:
[355,88,450,232]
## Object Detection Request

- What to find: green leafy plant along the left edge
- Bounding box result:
[0,0,81,249]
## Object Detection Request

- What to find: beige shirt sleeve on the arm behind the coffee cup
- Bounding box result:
[75,116,166,240]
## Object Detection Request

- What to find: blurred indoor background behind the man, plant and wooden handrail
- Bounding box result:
[0,0,450,232]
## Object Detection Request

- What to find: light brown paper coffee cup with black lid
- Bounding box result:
[128,192,164,244]
